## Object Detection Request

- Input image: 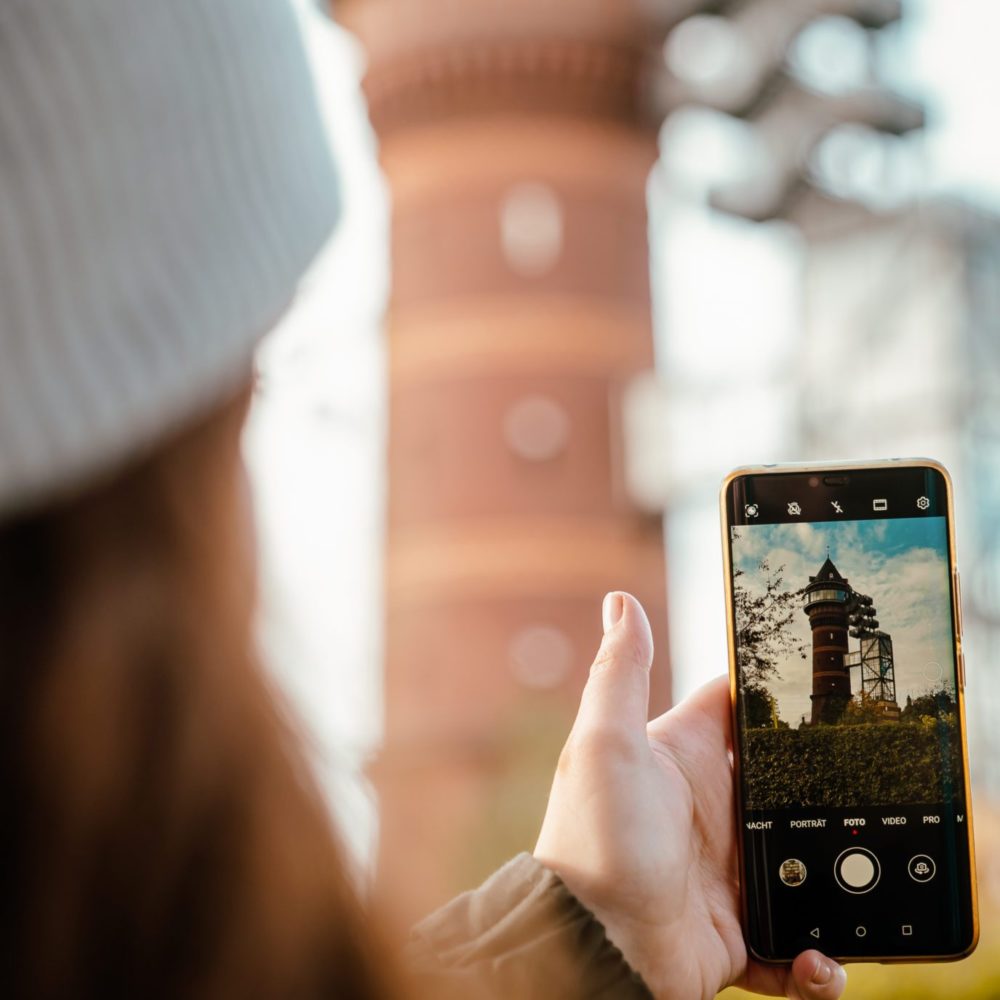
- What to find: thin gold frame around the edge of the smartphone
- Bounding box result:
[719,458,979,965]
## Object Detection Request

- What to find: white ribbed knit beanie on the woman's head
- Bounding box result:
[0,0,339,516]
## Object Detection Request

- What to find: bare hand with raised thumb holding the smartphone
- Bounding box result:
[535,593,847,1000]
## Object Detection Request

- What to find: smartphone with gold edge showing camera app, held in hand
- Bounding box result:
[721,459,979,962]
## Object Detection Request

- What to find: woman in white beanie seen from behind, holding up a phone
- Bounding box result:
[0,0,844,1000]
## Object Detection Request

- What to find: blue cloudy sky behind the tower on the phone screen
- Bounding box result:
[732,517,954,725]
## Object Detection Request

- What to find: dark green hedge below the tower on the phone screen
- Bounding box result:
[743,719,962,809]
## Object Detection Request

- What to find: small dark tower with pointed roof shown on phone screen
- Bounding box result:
[805,557,853,726]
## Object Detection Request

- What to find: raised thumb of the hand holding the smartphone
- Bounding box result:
[573,591,653,740]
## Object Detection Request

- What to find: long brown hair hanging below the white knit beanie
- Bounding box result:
[0,393,385,998]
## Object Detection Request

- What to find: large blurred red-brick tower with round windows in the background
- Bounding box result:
[336,0,670,922]
